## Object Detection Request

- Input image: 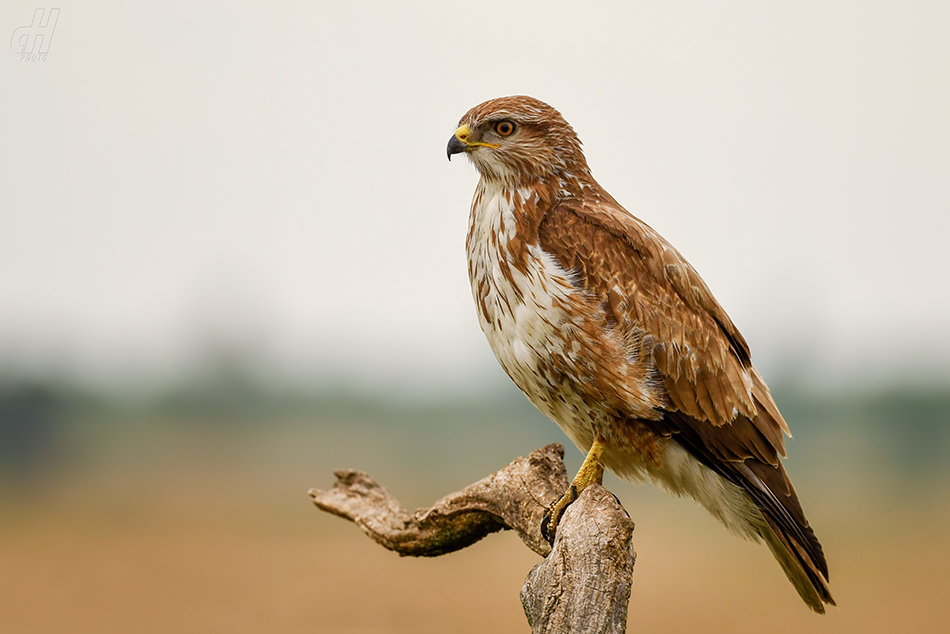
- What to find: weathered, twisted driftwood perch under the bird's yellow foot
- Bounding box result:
[310,444,636,634]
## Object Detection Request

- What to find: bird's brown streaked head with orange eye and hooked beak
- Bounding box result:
[446,96,589,183]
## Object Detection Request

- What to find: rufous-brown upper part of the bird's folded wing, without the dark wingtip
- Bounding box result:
[538,192,788,446]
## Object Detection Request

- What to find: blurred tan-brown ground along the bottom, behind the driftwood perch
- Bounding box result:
[0,442,950,634]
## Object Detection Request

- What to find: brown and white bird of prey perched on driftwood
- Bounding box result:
[447,96,834,612]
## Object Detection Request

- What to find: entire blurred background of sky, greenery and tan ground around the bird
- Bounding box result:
[0,0,950,634]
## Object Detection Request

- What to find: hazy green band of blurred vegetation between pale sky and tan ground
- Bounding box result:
[0,372,950,503]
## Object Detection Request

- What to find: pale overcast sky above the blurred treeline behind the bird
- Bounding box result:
[0,0,950,389]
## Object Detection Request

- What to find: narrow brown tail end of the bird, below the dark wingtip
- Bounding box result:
[760,513,835,614]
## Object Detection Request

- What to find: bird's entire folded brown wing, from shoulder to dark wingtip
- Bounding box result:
[538,188,831,607]
